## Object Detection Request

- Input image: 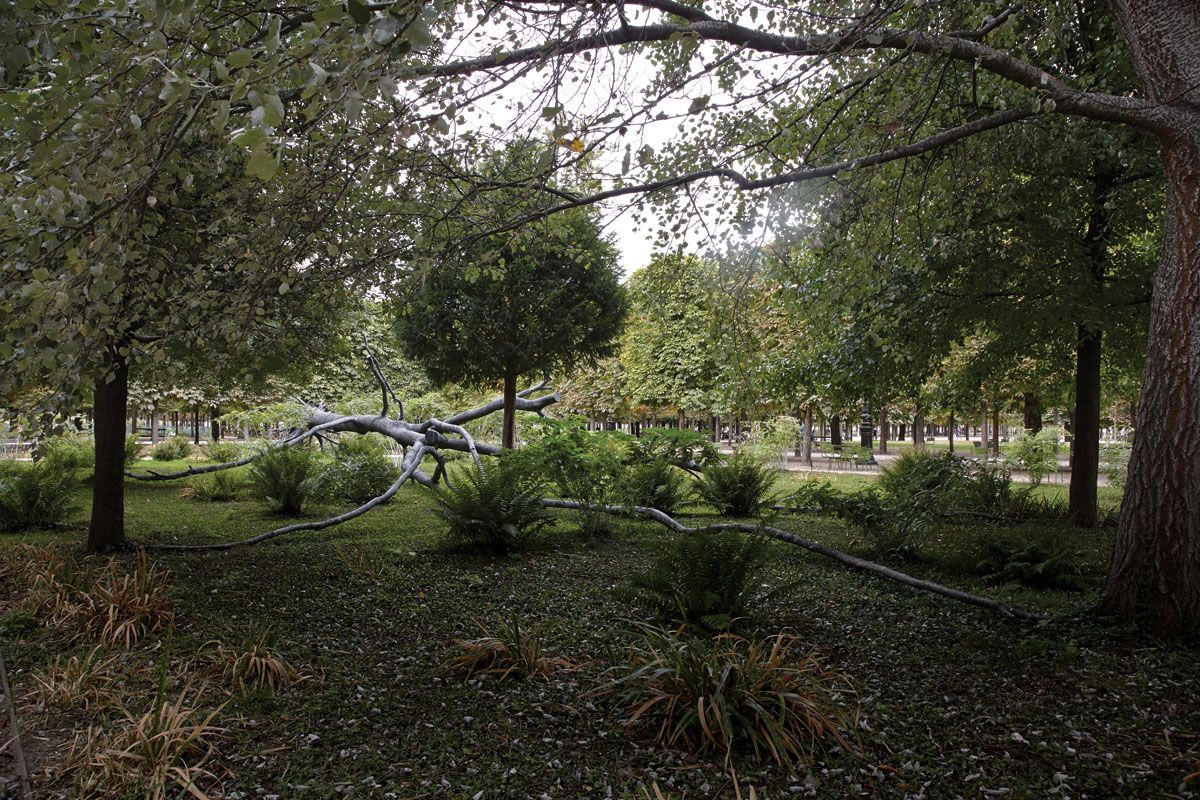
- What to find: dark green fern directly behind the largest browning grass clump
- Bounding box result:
[618,530,769,631]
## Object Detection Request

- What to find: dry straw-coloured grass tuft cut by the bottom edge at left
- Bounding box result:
[71,686,224,800]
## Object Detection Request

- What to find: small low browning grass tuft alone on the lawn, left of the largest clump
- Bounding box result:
[443,618,576,682]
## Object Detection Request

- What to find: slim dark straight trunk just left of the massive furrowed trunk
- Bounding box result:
[1068,327,1102,528]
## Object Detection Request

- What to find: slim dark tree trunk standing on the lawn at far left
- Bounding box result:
[88,351,130,553]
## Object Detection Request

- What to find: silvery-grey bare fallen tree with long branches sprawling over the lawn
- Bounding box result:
[126,350,1049,620]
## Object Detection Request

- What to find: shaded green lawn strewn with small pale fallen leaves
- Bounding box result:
[0,464,1200,800]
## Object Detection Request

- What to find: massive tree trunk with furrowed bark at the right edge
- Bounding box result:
[1100,0,1200,636]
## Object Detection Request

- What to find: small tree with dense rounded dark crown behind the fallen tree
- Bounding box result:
[398,211,626,449]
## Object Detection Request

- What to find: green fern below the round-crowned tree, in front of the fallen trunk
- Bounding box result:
[433,462,550,554]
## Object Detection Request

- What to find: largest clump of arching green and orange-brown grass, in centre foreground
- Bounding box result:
[596,626,852,768]
